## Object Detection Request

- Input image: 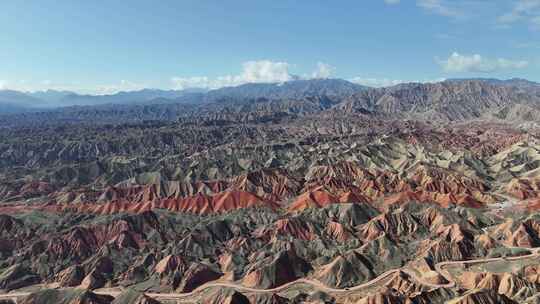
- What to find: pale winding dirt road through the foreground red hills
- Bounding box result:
[0,247,540,300]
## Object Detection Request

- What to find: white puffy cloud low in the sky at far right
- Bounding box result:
[437,52,529,73]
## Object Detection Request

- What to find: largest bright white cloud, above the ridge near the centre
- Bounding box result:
[171,60,295,90]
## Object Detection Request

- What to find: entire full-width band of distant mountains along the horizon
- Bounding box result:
[0,79,540,126]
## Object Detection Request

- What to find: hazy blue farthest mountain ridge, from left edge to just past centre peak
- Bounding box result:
[0,79,365,114]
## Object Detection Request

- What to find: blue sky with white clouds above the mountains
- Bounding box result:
[0,0,540,94]
